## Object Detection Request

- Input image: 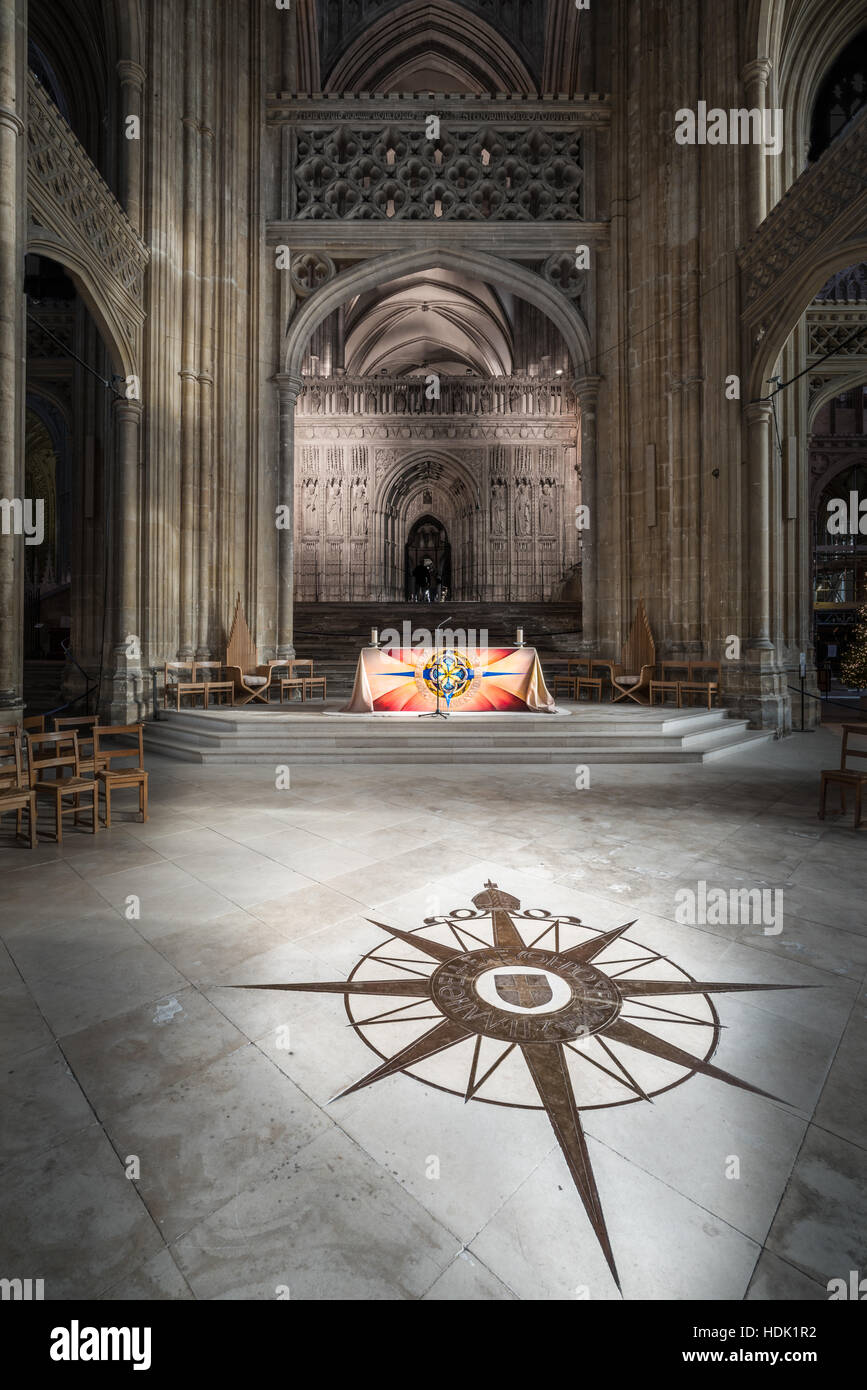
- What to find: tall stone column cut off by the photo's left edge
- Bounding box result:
[0,0,26,724]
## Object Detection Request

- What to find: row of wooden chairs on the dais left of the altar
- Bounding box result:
[163,656,327,710]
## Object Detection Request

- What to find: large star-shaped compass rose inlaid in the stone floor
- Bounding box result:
[233,881,804,1289]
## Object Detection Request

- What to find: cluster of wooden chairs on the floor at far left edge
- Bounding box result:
[0,714,147,849]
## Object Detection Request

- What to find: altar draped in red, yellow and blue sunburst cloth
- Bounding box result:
[342,646,556,714]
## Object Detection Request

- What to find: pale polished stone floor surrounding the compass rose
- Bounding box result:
[0,730,867,1300]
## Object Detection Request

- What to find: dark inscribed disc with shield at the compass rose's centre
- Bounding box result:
[431,948,622,1043]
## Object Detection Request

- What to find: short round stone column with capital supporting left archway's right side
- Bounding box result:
[110,399,142,723]
